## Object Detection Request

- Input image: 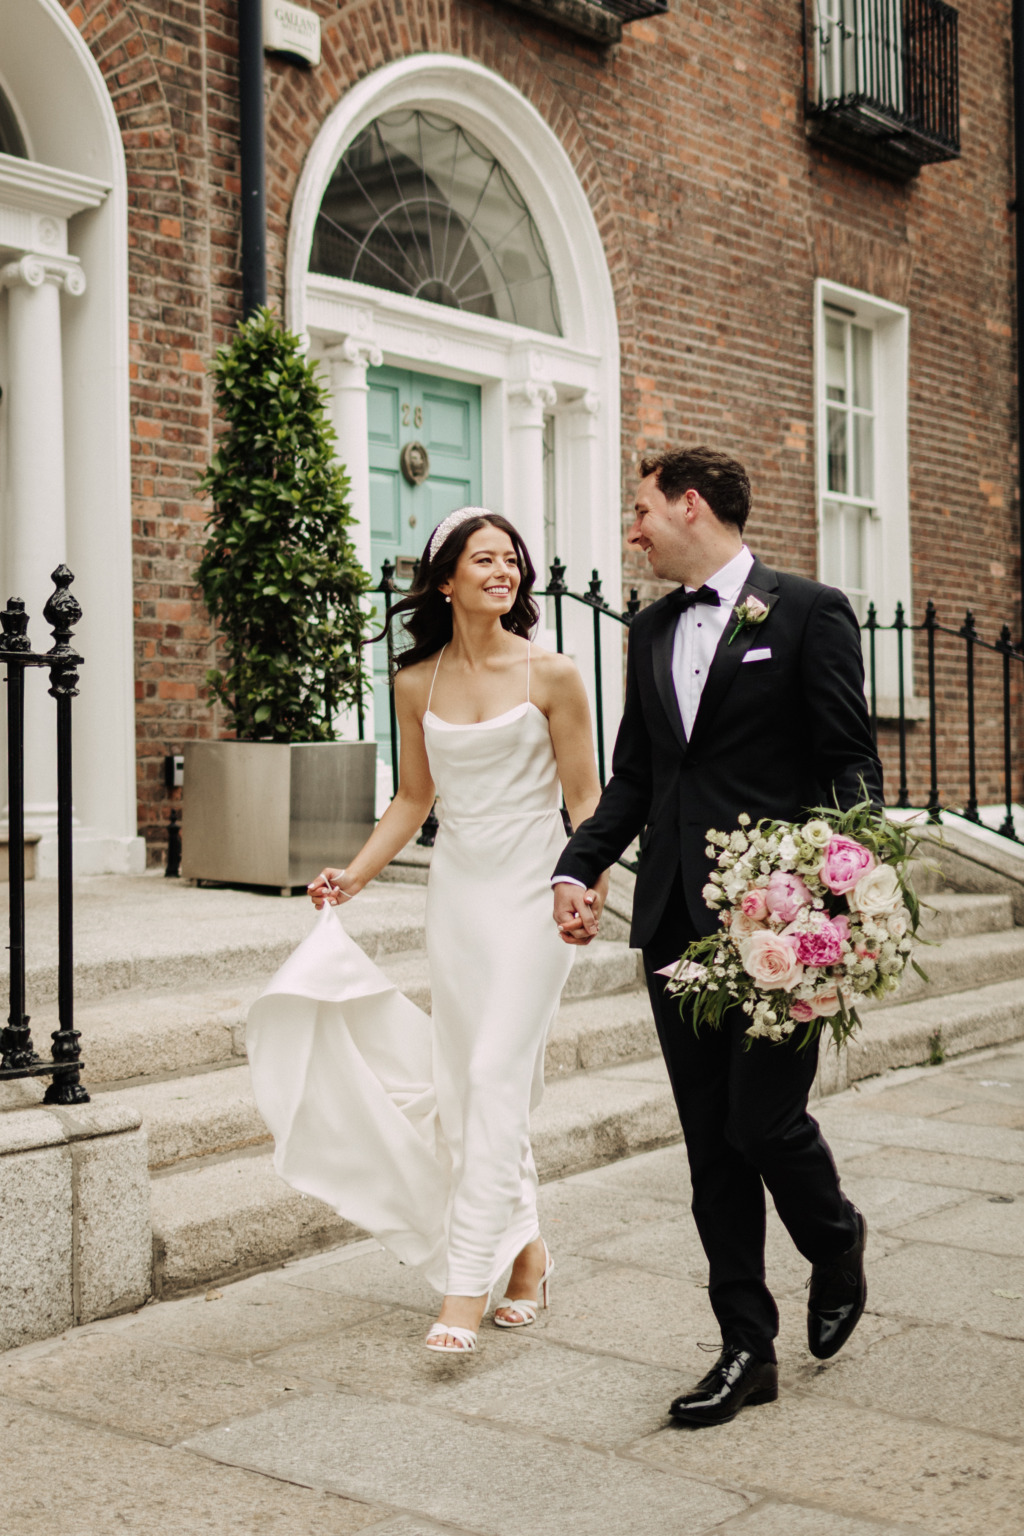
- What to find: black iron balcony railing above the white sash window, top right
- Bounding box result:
[804,0,960,177]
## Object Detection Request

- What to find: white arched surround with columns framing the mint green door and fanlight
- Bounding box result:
[286,54,622,733]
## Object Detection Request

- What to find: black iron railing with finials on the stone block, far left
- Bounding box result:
[0,565,89,1104]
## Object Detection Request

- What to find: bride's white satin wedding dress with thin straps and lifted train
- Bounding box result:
[247,651,573,1296]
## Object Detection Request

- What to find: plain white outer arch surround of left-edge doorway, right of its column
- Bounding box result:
[0,0,144,872]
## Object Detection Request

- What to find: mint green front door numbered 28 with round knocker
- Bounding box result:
[367,369,481,774]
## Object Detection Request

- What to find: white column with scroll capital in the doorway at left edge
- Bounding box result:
[0,255,86,831]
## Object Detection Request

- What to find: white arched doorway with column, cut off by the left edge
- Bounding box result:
[0,0,144,874]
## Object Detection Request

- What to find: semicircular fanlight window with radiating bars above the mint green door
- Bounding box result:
[310,111,562,336]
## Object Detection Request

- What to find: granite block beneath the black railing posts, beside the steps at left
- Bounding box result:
[0,1100,152,1350]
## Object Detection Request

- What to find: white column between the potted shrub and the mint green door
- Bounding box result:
[324,336,382,740]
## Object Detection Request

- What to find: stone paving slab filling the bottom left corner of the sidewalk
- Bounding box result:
[0,1399,385,1536]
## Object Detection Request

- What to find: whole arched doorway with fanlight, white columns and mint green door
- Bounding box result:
[287,54,622,780]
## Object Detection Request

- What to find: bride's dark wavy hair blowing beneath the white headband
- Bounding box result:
[367,511,540,671]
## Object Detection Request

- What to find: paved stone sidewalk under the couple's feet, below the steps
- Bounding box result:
[0,1044,1024,1536]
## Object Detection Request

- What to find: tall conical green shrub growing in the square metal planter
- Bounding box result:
[197,309,370,742]
